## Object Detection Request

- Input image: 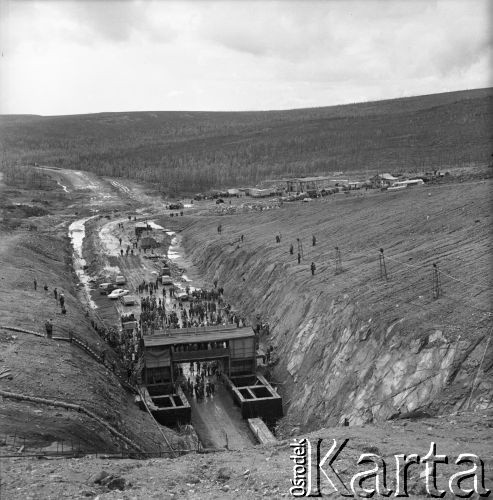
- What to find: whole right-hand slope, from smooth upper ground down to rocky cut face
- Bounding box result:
[183,181,493,430]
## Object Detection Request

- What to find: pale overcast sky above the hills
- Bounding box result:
[0,0,493,115]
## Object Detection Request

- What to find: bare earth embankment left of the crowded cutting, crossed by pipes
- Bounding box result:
[0,175,181,453]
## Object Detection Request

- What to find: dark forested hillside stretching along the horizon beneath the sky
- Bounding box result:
[0,88,493,193]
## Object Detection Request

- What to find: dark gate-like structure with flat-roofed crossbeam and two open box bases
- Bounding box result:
[143,325,283,425]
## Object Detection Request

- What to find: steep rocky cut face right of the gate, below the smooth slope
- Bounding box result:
[182,205,491,436]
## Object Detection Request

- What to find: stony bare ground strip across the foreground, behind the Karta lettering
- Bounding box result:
[1,412,493,500]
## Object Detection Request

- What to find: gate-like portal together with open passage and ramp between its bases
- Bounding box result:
[143,325,282,447]
